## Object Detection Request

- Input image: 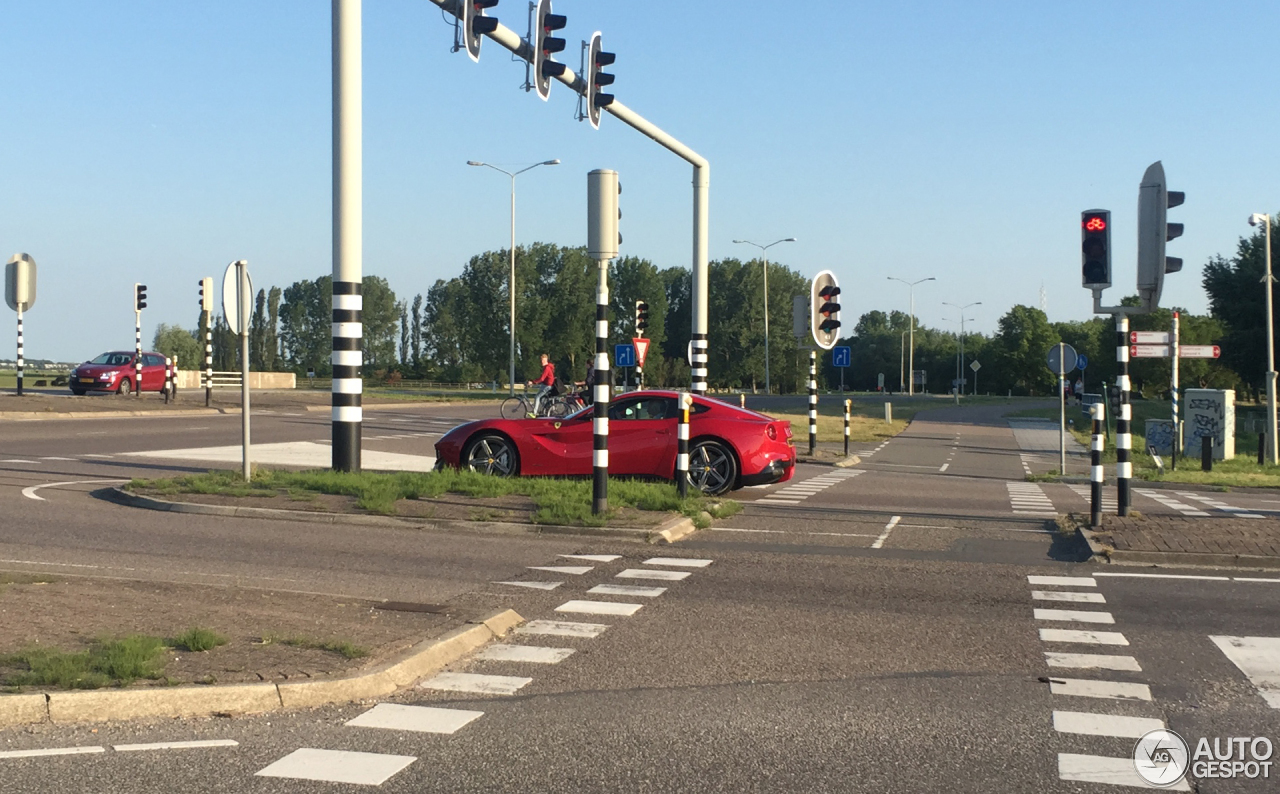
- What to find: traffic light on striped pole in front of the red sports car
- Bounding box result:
[586,169,622,515]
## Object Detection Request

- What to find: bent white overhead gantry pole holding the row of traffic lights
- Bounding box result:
[430,0,710,394]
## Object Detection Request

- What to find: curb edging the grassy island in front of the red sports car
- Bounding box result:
[102,487,694,543]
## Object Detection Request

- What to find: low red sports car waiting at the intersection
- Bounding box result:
[435,392,796,494]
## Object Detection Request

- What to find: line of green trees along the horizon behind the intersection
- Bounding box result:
[155,221,1276,396]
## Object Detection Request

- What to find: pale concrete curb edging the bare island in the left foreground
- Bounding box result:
[0,610,525,727]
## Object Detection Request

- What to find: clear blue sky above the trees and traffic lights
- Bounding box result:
[0,0,1280,360]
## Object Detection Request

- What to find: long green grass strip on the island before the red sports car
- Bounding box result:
[127,469,732,526]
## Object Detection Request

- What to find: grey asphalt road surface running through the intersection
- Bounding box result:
[0,406,1280,793]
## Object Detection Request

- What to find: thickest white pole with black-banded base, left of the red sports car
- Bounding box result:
[330,0,364,471]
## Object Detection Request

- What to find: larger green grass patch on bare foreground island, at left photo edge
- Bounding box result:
[0,634,165,689]
